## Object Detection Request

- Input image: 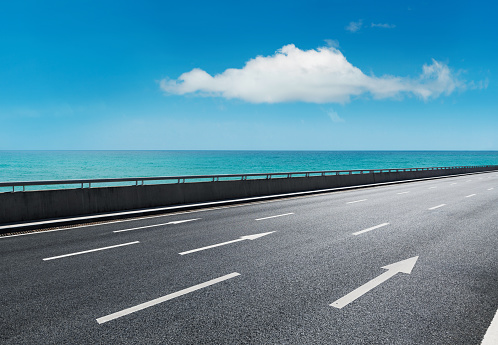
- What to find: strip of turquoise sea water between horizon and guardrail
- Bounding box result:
[0,151,498,182]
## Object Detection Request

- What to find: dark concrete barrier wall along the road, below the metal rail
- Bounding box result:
[0,167,496,224]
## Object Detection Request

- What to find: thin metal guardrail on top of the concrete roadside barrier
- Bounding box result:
[0,165,498,192]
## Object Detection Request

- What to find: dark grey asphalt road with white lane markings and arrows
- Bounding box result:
[0,173,498,345]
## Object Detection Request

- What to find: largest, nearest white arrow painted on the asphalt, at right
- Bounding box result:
[330,256,418,309]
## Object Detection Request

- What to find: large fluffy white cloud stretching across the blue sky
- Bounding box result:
[160,44,465,103]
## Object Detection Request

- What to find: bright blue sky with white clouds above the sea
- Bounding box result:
[0,0,498,150]
